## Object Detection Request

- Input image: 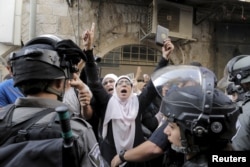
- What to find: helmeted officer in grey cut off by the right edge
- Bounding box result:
[226,55,250,151]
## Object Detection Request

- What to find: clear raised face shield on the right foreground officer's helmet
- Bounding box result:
[151,65,215,117]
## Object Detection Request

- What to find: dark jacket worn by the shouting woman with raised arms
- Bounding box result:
[85,51,168,166]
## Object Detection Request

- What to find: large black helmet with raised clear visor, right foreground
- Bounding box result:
[152,65,240,153]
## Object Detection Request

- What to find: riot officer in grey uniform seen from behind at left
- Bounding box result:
[0,35,108,167]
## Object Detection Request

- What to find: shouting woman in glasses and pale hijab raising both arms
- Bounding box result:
[83,22,174,167]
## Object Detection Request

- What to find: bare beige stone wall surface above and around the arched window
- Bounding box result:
[0,0,248,83]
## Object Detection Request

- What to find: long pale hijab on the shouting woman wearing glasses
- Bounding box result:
[102,75,139,153]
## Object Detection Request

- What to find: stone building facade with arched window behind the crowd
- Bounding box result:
[0,0,249,88]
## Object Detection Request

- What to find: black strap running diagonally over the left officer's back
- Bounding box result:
[0,108,55,146]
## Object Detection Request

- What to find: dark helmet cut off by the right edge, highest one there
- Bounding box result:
[226,55,250,85]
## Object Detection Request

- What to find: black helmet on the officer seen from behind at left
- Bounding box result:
[10,35,86,86]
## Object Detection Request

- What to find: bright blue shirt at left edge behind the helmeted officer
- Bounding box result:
[0,78,23,107]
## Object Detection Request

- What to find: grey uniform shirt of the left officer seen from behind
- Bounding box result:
[9,98,105,166]
